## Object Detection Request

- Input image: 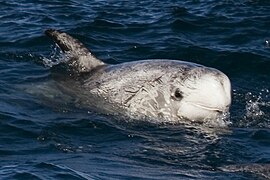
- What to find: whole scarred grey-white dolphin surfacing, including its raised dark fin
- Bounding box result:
[45,29,231,122]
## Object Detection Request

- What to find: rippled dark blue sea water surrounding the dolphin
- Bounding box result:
[0,0,270,179]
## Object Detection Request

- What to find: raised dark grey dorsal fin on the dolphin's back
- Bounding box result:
[45,29,105,73]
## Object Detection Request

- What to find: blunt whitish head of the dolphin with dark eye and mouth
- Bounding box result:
[168,66,231,122]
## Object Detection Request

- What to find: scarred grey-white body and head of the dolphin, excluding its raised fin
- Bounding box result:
[83,60,231,122]
